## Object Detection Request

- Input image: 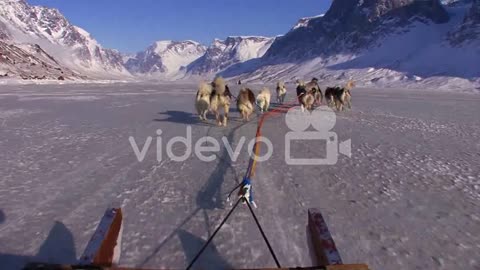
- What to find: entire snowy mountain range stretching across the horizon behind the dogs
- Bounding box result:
[0,0,480,87]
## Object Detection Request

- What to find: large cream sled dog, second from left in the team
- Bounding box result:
[210,77,231,127]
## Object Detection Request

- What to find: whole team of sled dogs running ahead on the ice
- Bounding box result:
[195,77,355,126]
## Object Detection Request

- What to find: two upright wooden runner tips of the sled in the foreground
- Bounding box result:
[23,208,368,270]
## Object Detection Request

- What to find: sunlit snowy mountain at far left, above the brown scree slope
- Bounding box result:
[0,0,129,77]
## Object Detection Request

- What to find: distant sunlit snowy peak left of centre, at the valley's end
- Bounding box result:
[125,40,206,76]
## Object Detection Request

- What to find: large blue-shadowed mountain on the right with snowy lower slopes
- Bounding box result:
[222,0,480,89]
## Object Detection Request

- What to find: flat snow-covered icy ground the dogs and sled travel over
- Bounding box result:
[0,84,480,270]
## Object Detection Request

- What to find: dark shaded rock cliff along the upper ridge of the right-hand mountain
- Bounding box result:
[265,0,449,61]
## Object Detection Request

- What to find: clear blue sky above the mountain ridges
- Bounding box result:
[27,0,331,52]
